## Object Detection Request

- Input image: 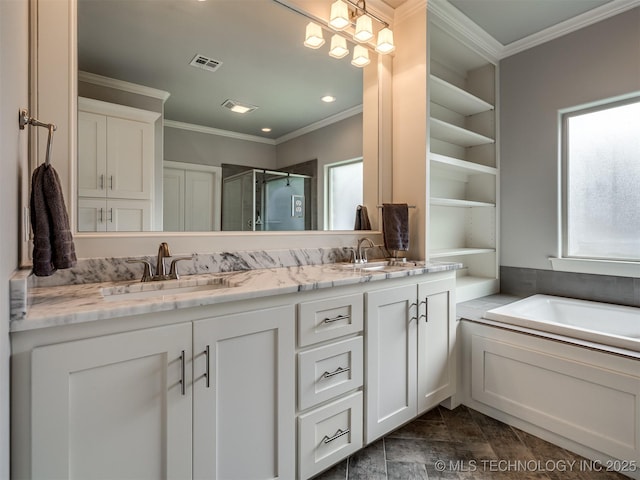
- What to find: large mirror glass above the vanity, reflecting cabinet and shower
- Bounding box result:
[76,0,368,232]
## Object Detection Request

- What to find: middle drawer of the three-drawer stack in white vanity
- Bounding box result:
[298,337,363,410]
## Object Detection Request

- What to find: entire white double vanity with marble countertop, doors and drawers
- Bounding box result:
[11,248,459,479]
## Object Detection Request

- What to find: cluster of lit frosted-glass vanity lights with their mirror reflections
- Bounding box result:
[300,0,396,67]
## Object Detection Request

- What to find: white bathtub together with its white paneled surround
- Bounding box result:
[459,295,640,480]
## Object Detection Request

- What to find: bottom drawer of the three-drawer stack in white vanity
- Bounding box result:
[298,392,362,479]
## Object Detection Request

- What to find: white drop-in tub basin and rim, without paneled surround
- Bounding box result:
[484,295,640,352]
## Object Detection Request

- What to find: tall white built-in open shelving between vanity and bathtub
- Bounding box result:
[427,22,499,302]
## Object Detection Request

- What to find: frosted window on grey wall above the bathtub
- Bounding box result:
[562,96,640,261]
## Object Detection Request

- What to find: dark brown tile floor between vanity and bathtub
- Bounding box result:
[314,406,628,480]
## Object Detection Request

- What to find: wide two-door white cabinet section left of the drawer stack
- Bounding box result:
[12,302,296,480]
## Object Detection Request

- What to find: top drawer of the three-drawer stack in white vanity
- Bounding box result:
[298,294,363,347]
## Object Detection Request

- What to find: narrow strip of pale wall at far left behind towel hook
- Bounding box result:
[0,0,30,479]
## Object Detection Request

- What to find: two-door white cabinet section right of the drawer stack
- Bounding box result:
[365,274,456,443]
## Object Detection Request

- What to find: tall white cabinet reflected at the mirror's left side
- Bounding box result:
[77,97,160,231]
